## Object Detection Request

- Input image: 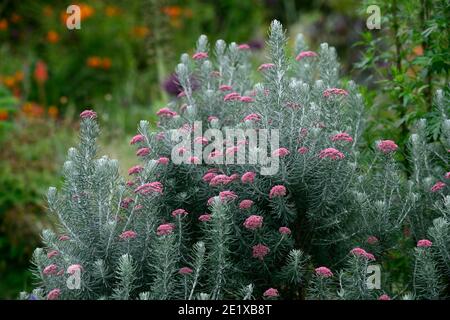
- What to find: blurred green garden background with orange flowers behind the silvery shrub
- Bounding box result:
[0,0,450,299]
